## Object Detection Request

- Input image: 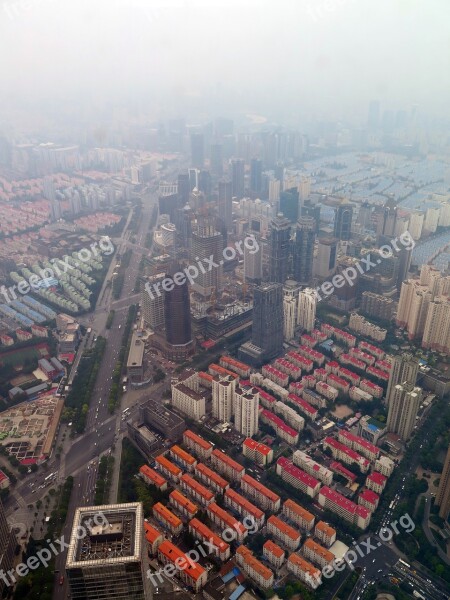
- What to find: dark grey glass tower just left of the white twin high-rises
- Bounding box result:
[252,283,283,360]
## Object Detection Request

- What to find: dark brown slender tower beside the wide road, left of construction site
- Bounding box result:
[164,264,193,355]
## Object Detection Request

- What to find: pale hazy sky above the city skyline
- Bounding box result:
[0,0,450,123]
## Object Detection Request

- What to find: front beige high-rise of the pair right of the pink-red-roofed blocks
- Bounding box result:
[386,381,422,442]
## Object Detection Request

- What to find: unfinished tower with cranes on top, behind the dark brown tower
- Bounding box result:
[191,219,223,299]
